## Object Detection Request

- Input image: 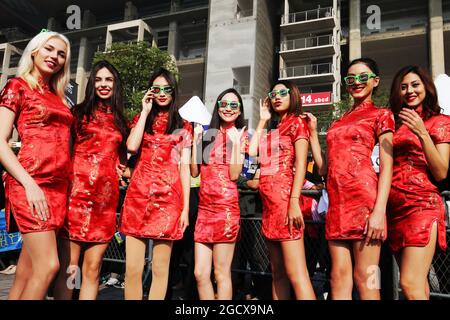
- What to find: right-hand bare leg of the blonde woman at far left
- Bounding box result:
[15,231,59,300]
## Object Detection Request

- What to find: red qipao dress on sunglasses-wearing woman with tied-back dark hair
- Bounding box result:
[325,101,395,240]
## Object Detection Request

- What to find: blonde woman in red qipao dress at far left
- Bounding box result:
[0,32,73,300]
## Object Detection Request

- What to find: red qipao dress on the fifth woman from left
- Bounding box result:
[259,115,310,241]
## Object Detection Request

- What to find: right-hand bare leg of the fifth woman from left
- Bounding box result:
[280,239,316,300]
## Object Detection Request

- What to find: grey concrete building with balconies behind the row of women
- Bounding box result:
[0,0,450,127]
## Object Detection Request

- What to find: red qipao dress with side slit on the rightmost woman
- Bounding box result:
[387,115,450,252]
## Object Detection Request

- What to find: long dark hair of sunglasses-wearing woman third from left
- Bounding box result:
[145,68,183,134]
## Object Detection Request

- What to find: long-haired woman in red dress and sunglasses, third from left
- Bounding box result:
[120,69,192,300]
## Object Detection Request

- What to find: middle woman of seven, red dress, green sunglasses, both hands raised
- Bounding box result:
[191,89,248,300]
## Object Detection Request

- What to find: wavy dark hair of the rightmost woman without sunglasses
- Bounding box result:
[389,66,441,122]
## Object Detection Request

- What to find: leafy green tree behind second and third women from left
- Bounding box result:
[93,41,179,119]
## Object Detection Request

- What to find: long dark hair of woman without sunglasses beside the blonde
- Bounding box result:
[72,60,128,143]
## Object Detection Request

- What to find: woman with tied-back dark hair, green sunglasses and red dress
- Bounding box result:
[307,58,395,300]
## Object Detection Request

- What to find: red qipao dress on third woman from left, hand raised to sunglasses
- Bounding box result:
[120,112,192,240]
